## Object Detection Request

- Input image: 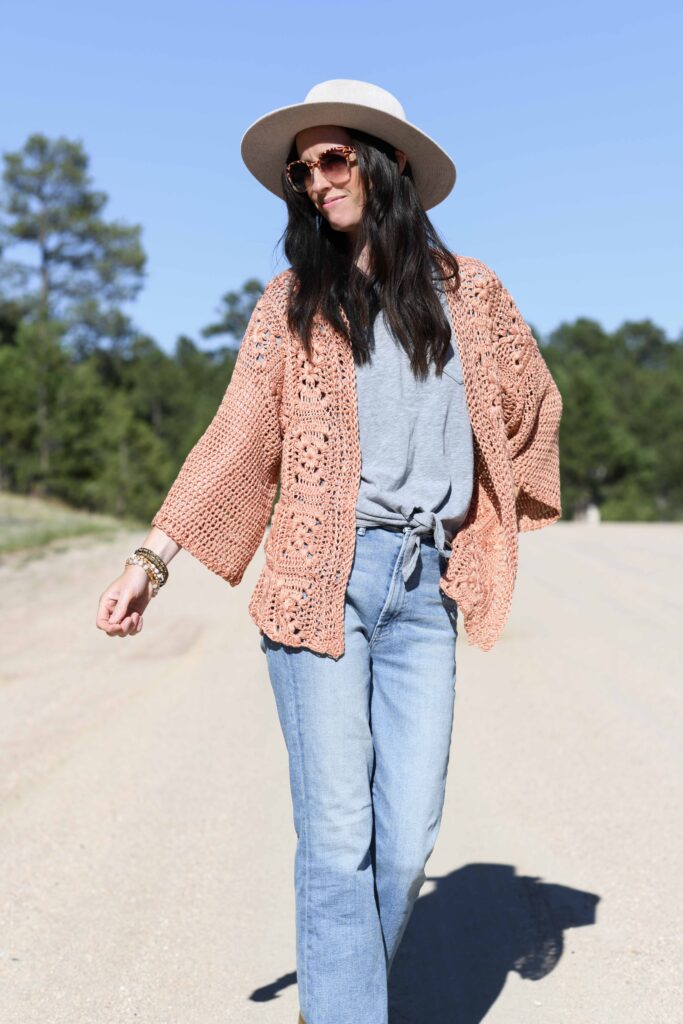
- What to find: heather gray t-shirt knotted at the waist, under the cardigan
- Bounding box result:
[355,283,474,580]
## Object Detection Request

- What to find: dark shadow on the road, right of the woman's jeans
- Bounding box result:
[389,864,600,1024]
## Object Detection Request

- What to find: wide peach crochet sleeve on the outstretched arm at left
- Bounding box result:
[152,275,287,587]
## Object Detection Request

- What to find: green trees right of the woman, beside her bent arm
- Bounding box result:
[544,317,683,521]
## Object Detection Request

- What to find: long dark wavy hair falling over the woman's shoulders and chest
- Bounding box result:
[278,128,460,378]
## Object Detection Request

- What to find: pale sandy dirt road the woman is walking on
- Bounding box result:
[0,523,683,1024]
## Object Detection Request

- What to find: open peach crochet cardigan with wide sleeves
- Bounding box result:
[152,256,562,658]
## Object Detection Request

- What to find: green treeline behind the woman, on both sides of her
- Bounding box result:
[0,134,683,521]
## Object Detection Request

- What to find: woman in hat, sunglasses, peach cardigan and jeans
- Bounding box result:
[97,80,561,1024]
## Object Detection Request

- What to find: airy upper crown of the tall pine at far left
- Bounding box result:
[0,133,145,354]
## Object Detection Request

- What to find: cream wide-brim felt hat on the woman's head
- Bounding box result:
[241,78,456,210]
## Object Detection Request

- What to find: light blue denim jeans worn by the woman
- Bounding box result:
[261,526,458,1024]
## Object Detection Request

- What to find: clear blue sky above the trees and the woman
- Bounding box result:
[0,0,683,350]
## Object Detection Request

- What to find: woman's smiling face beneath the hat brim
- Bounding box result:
[296,125,365,237]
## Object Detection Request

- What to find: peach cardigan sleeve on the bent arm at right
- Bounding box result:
[490,276,562,531]
